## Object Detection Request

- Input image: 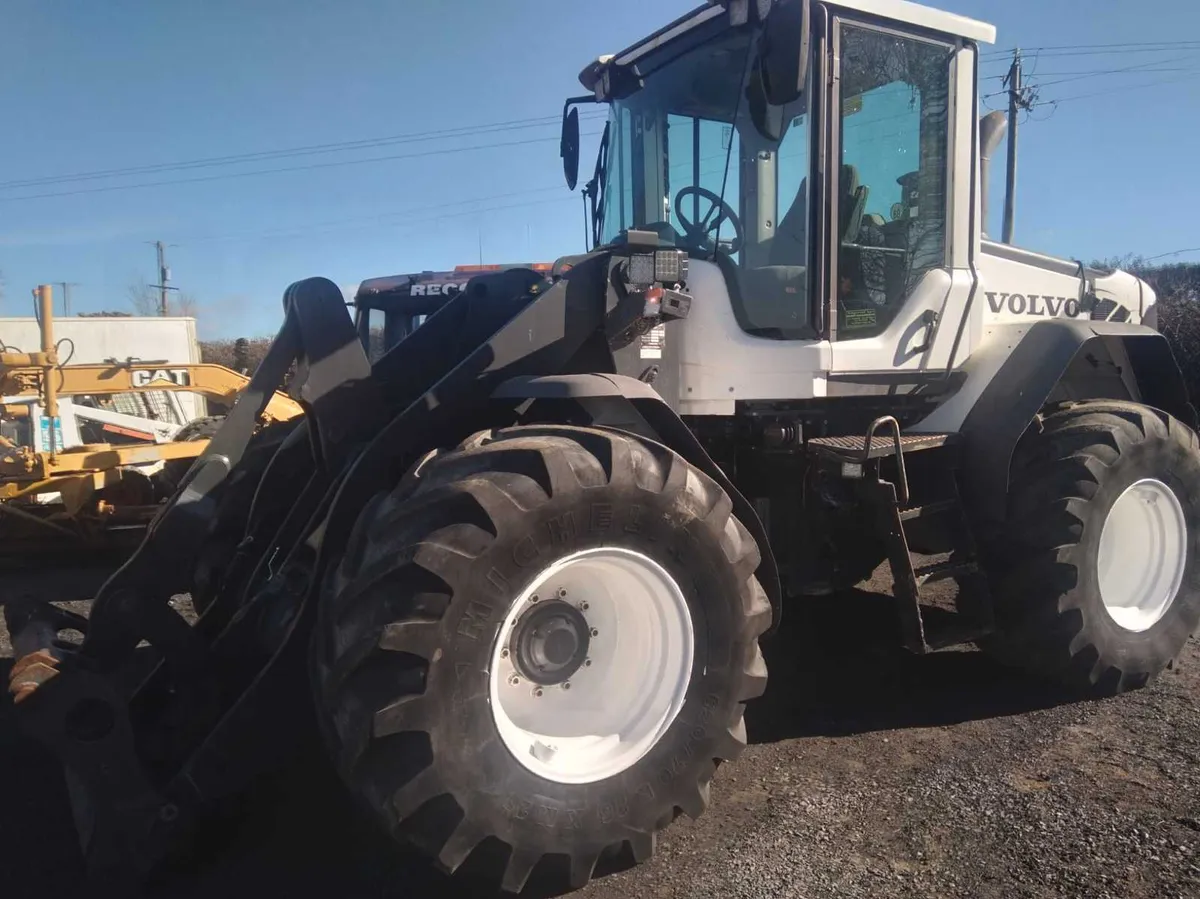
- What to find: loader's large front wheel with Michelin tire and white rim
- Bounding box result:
[313,426,770,892]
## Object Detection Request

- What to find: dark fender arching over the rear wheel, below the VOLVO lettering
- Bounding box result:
[959,319,1196,531]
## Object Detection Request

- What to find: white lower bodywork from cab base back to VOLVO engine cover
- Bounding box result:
[662,244,1156,415]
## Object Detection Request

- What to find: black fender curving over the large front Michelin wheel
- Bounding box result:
[492,373,784,634]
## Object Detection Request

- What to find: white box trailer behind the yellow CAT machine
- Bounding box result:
[0,317,208,421]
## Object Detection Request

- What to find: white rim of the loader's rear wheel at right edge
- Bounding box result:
[1097,478,1188,631]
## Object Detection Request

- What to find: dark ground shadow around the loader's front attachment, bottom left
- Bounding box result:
[0,659,580,899]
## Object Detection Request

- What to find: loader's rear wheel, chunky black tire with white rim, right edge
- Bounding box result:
[980,401,1200,694]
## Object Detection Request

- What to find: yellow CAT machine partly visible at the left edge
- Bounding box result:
[0,286,304,563]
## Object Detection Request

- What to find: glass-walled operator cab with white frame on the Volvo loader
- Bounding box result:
[564,0,995,414]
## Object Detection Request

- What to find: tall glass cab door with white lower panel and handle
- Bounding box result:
[827,17,973,384]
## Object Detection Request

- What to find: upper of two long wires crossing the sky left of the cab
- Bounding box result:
[0,115,604,190]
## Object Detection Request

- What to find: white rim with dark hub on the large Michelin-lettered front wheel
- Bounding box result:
[488,547,694,784]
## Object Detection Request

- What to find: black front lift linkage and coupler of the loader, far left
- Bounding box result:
[5,278,382,879]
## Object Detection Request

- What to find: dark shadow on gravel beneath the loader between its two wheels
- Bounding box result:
[746,591,1080,743]
